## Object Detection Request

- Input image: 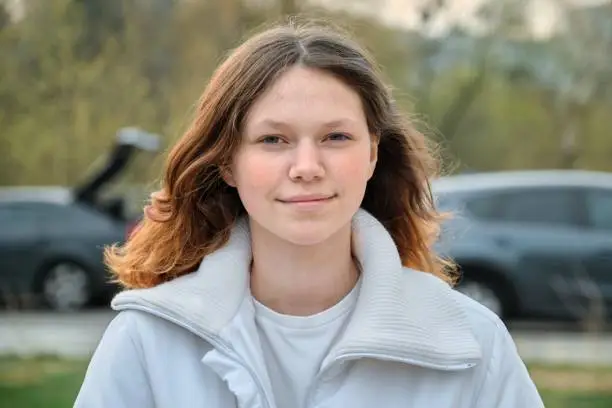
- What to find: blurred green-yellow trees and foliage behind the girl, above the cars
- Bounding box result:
[0,0,612,185]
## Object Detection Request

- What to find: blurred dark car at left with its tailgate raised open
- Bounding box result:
[0,129,157,310]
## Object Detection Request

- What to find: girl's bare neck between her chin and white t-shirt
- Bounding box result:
[251,220,359,316]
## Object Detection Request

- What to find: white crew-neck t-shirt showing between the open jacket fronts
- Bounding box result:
[254,282,360,408]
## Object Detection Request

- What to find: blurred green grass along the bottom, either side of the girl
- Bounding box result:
[0,356,612,408]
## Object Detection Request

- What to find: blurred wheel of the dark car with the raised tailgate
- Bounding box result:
[41,261,92,310]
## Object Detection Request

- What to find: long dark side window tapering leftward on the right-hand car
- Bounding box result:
[466,188,581,226]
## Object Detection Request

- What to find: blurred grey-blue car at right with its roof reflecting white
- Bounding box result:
[432,170,612,320]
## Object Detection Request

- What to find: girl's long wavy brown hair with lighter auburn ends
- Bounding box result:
[105,22,452,288]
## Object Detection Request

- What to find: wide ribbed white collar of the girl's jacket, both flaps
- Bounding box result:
[111,210,481,369]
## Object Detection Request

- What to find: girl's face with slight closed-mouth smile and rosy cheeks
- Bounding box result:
[224,66,377,245]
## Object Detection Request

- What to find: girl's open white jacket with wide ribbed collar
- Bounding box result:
[75,210,544,408]
